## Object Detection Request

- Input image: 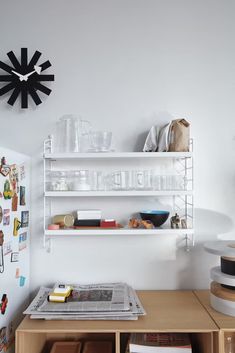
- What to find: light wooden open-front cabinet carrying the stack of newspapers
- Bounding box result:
[16,291,219,353]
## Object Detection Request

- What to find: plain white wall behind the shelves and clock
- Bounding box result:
[0,0,235,289]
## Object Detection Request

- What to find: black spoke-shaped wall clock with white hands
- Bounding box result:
[0,48,55,109]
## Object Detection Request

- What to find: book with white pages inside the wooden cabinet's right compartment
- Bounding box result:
[128,332,192,353]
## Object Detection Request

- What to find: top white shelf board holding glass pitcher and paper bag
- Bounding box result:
[44,152,193,160]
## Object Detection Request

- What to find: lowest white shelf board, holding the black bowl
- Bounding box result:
[45,228,194,238]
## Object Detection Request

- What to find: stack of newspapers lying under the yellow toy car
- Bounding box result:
[24,283,146,320]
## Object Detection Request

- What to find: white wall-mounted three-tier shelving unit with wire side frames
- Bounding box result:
[43,139,194,251]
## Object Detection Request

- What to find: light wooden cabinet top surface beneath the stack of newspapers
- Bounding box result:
[17,290,218,333]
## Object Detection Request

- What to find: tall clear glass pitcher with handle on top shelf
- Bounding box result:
[56,115,91,152]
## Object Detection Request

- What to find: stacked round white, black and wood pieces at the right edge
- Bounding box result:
[204,240,235,316]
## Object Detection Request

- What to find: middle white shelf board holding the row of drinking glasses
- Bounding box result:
[44,190,193,197]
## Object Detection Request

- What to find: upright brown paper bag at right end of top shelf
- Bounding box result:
[168,119,190,152]
